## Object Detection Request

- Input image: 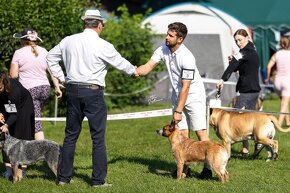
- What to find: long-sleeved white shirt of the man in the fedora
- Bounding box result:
[47,29,135,86]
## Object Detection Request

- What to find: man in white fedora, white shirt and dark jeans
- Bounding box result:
[47,10,137,187]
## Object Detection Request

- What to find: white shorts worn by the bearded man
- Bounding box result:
[172,95,207,131]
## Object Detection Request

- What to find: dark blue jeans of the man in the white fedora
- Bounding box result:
[57,84,107,185]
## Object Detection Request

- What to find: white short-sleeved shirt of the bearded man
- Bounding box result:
[151,44,206,101]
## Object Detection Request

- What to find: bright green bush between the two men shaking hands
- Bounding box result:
[101,5,161,108]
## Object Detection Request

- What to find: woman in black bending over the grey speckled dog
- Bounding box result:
[0,72,35,178]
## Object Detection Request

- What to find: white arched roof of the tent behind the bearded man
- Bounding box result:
[143,2,247,34]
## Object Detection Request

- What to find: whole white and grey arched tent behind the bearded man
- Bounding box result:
[143,3,247,103]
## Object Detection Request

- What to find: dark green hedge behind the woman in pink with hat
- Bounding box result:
[0,0,87,68]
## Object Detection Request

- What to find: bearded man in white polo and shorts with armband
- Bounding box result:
[137,22,212,179]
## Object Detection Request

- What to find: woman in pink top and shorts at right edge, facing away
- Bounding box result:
[265,36,290,126]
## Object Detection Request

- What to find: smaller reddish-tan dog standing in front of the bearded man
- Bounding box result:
[156,123,229,183]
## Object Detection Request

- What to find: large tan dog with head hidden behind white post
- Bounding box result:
[209,108,290,161]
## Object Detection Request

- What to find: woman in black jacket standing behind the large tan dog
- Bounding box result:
[217,29,262,156]
